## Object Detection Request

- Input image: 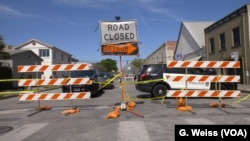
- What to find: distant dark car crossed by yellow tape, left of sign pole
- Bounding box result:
[99,72,115,89]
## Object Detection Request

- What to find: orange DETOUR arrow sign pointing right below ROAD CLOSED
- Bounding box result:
[102,43,138,55]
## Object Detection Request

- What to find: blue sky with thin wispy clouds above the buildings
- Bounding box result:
[0,0,250,66]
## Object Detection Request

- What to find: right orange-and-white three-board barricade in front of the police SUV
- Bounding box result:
[163,61,241,109]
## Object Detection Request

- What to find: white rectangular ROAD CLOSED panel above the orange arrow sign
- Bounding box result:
[100,21,138,45]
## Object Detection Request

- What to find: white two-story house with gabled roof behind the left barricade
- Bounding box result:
[16,39,77,79]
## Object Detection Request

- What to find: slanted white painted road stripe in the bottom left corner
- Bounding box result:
[0,123,48,141]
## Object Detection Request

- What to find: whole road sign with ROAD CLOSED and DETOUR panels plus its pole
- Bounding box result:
[99,16,143,117]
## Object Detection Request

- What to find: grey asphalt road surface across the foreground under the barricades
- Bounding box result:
[0,81,250,141]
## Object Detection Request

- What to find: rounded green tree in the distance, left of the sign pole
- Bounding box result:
[98,58,118,72]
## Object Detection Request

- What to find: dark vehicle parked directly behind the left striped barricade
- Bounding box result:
[62,69,103,97]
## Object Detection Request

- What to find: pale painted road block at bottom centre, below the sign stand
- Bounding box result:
[117,121,151,141]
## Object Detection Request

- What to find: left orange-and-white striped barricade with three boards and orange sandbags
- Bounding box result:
[18,63,92,115]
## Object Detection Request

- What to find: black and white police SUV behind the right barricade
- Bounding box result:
[135,64,237,97]
